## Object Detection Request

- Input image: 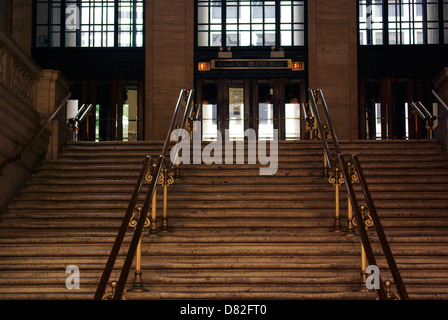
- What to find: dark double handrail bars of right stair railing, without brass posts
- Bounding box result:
[309,89,409,300]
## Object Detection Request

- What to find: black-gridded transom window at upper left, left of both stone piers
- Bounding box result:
[35,0,144,47]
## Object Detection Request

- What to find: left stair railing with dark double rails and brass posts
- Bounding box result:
[94,89,199,300]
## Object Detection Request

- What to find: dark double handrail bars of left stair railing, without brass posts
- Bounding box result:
[94,89,194,300]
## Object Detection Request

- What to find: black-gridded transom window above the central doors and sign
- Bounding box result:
[196,0,305,47]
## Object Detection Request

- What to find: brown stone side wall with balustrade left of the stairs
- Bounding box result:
[0,30,69,210]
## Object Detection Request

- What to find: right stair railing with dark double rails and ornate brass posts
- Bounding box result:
[309,89,409,300]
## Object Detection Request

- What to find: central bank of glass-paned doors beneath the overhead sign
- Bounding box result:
[196,78,306,141]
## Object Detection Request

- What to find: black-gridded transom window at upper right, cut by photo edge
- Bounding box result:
[359,0,448,45]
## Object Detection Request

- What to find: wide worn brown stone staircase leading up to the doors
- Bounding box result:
[0,140,448,300]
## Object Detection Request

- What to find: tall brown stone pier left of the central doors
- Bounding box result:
[145,0,194,140]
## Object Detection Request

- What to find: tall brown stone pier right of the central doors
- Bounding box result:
[308,0,358,140]
